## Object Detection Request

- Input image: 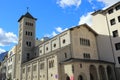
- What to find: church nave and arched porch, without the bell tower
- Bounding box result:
[21,24,116,80]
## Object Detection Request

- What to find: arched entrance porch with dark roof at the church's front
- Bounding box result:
[60,59,116,80]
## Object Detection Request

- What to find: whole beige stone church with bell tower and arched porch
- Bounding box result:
[13,12,116,80]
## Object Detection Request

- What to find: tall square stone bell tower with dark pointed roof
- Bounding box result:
[18,12,37,63]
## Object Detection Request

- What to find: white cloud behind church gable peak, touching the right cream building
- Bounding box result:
[78,12,92,26]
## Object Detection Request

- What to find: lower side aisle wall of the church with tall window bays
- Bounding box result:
[21,55,58,80]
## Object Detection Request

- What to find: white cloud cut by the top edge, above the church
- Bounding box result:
[57,0,81,8]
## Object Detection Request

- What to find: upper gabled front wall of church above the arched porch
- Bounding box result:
[71,25,98,60]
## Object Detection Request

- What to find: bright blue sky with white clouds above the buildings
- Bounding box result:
[0,0,119,53]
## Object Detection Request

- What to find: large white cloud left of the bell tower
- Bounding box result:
[0,28,18,46]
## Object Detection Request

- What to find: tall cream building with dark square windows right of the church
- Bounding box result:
[92,1,120,80]
